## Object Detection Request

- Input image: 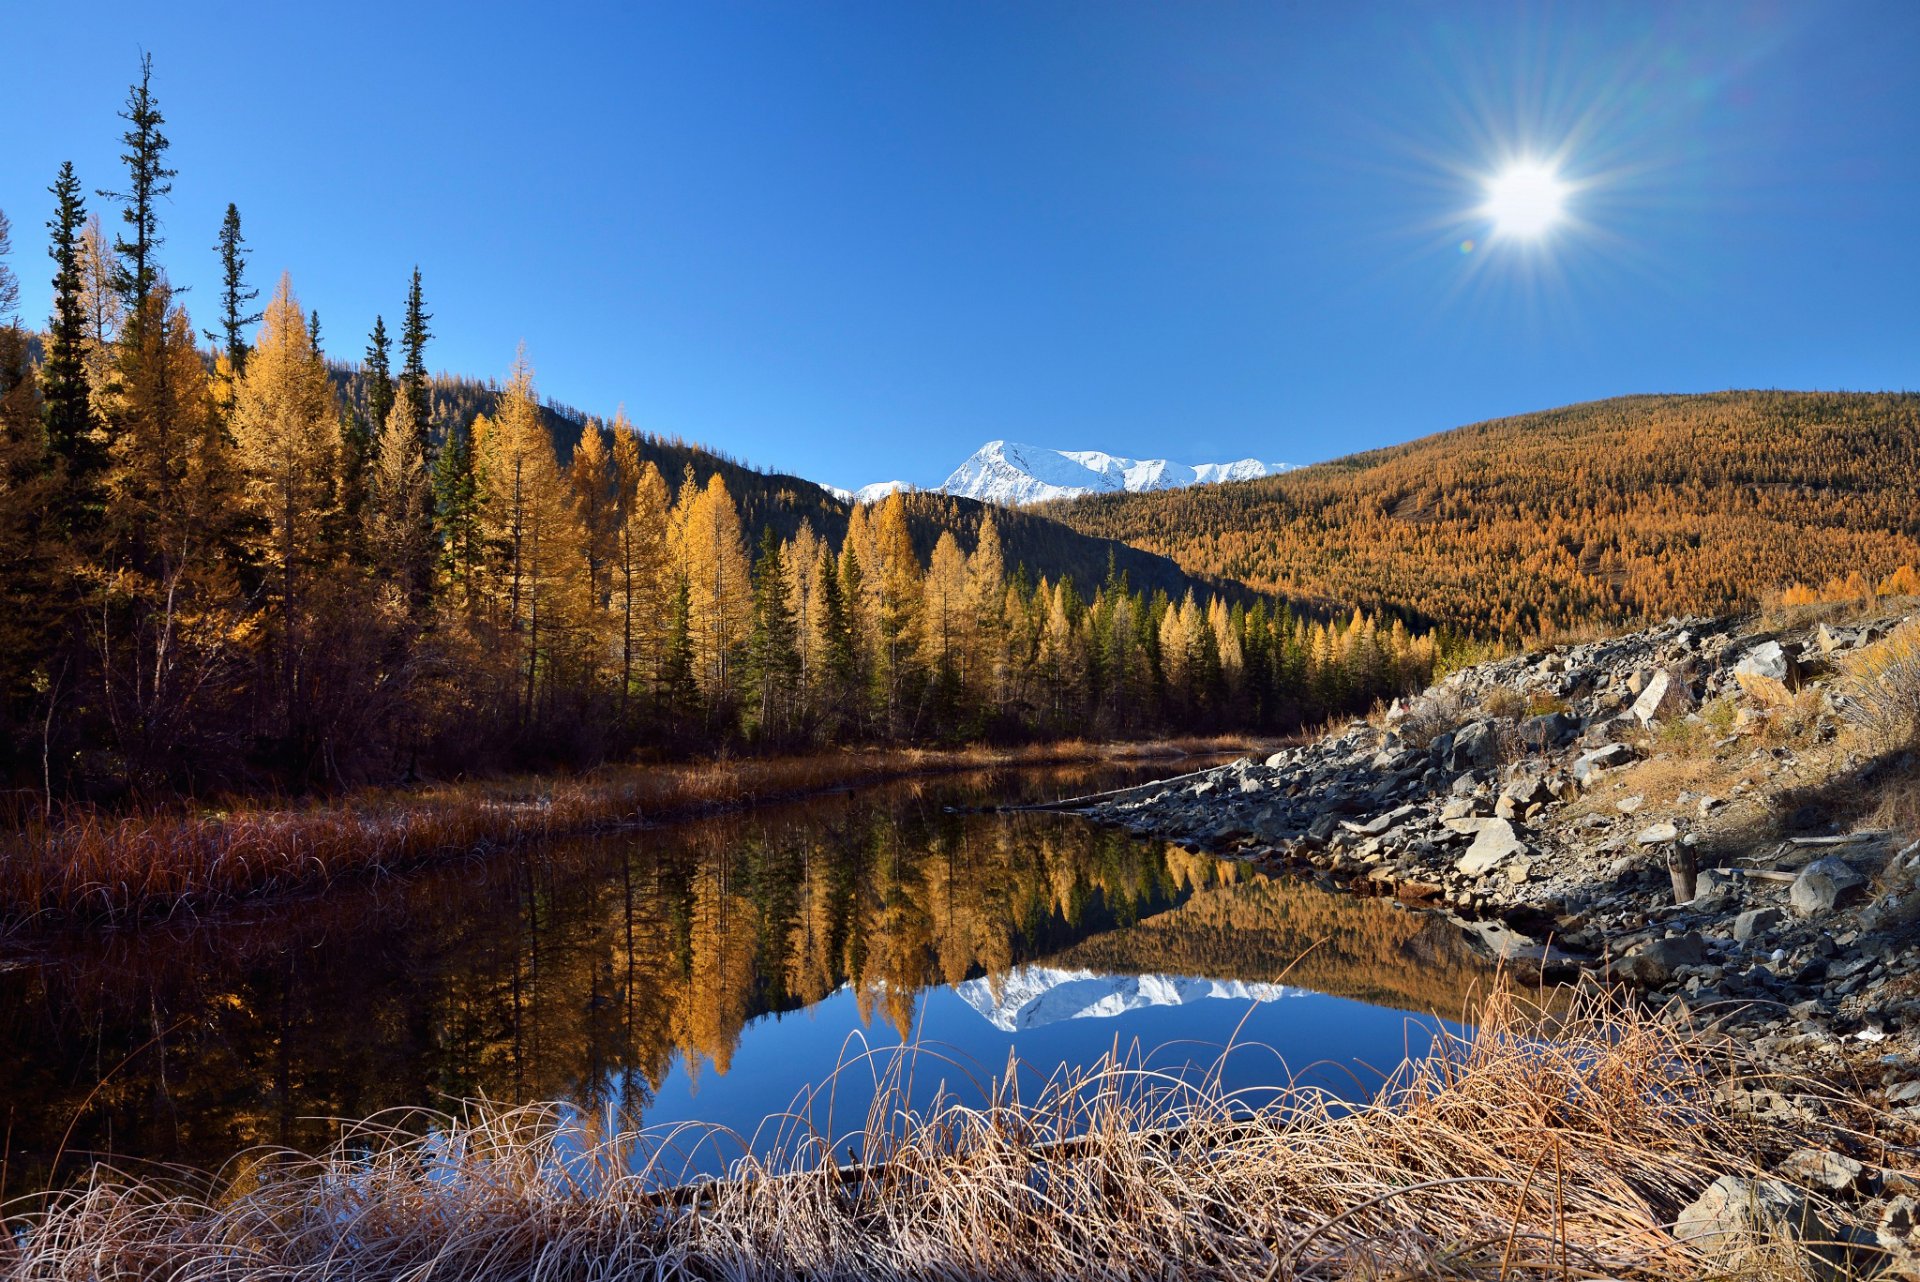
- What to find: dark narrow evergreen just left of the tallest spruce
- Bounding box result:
[40,161,106,514]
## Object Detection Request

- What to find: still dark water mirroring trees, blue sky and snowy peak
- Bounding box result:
[0,762,1488,1199]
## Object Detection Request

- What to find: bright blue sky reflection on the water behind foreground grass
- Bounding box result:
[583,977,1457,1173]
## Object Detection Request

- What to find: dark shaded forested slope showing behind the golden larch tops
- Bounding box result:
[330,361,1256,603]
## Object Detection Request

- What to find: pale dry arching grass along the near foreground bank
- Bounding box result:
[0,996,1889,1282]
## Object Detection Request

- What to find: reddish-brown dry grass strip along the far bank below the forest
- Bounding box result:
[0,741,1238,931]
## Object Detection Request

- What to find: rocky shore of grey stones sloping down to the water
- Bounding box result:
[1066,610,1920,1278]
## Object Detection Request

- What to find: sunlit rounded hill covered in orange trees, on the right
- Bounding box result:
[1037,392,1920,635]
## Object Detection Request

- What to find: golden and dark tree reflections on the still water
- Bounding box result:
[0,771,1497,1192]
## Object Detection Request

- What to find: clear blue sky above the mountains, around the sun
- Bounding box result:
[0,0,1920,484]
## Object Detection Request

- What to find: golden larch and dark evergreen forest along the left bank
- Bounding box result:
[0,61,1442,808]
